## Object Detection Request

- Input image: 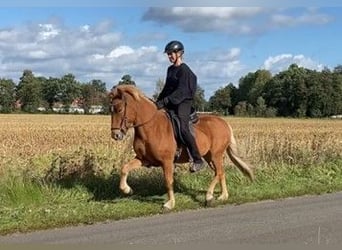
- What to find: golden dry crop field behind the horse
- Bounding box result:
[0,115,342,171]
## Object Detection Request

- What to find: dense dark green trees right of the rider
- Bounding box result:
[196,64,342,118]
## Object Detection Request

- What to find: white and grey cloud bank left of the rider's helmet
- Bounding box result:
[0,19,166,92]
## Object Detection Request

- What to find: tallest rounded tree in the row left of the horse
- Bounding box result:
[17,70,43,112]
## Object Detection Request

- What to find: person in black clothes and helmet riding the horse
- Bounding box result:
[156,41,204,172]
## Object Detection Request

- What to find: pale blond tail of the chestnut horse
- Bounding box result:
[227,125,254,181]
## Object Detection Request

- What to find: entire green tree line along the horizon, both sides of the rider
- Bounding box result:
[0,64,342,117]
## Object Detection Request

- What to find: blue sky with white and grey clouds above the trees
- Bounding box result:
[0,0,342,99]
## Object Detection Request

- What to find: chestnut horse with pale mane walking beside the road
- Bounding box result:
[109,85,254,210]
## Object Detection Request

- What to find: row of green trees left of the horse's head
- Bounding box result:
[0,70,108,113]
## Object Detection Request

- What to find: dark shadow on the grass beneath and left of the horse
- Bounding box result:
[39,152,205,204]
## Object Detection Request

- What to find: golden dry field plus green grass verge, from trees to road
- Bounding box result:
[0,115,342,234]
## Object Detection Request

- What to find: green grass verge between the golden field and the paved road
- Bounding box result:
[0,156,342,234]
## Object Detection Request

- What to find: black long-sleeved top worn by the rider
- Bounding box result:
[157,63,197,106]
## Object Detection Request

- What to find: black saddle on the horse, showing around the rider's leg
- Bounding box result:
[166,108,199,160]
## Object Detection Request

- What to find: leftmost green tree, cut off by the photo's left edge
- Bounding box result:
[0,79,15,113]
